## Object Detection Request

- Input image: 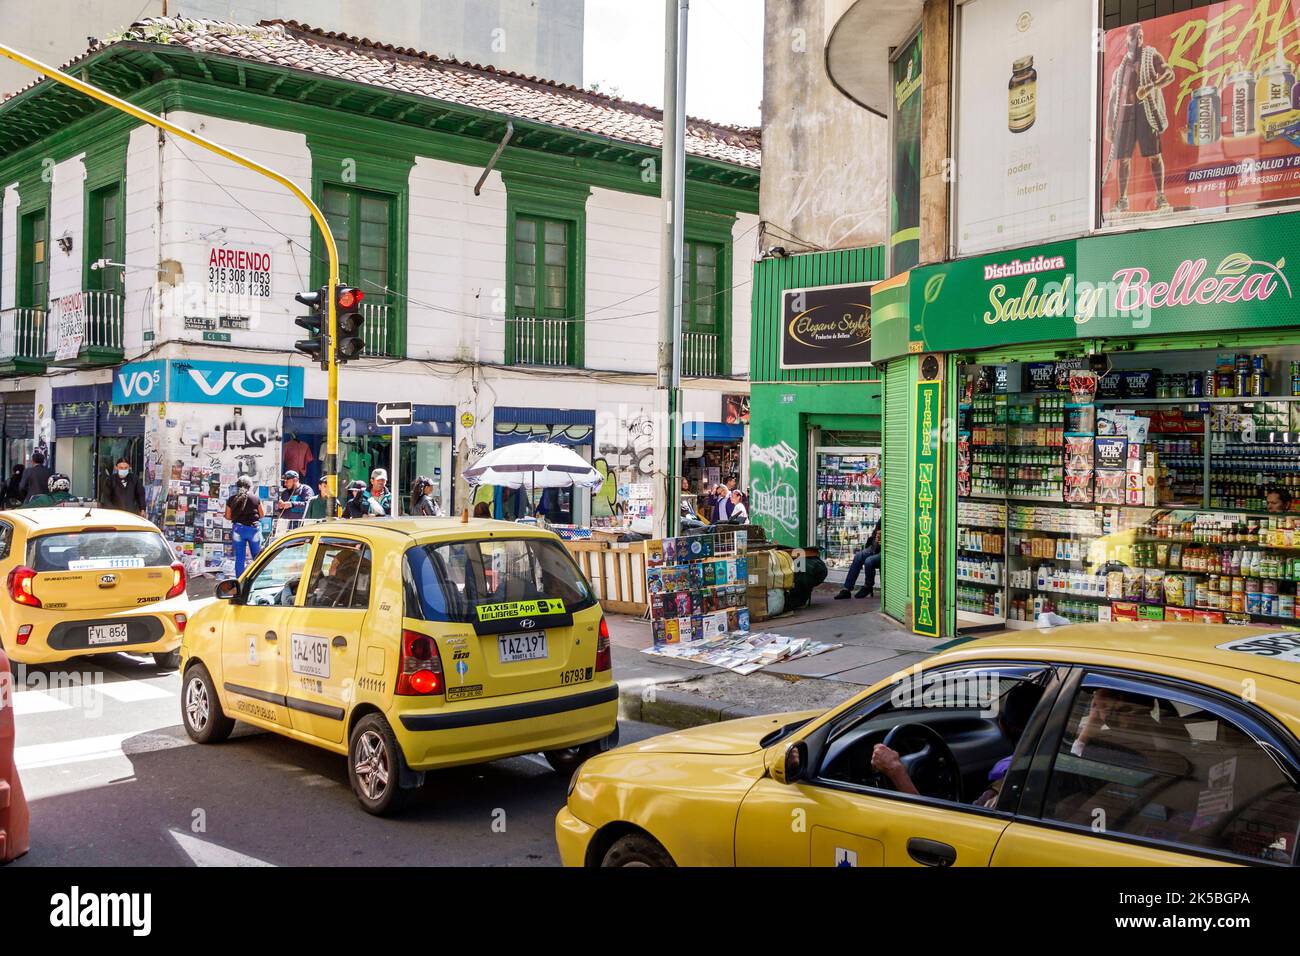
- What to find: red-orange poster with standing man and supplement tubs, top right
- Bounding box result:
[1097,0,1300,225]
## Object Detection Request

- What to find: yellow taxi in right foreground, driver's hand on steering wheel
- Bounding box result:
[555,622,1300,866]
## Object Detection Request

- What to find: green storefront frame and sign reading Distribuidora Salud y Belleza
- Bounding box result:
[872,213,1300,636]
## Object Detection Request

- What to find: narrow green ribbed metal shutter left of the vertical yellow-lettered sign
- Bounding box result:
[881,359,911,622]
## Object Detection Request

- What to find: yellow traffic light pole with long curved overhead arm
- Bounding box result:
[0,43,338,518]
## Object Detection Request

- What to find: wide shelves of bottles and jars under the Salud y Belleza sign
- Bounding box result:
[956,352,1300,627]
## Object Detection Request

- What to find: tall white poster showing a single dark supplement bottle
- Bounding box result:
[956,0,1096,255]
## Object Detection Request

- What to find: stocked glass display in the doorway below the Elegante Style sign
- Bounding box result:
[811,442,881,584]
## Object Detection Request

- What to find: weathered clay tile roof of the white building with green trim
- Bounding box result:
[112,17,759,169]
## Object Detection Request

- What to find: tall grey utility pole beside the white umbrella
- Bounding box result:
[655,0,690,537]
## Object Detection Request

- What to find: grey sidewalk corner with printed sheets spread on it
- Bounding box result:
[607,587,939,727]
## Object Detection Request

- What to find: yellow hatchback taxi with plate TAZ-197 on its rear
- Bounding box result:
[181,518,618,814]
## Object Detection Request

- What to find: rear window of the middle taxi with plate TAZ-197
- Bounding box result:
[403,537,595,624]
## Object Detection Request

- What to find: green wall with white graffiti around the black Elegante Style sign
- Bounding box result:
[749,247,885,572]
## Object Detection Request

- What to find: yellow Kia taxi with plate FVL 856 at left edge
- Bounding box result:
[0,507,190,669]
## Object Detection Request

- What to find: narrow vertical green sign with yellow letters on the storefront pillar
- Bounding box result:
[911,381,943,637]
